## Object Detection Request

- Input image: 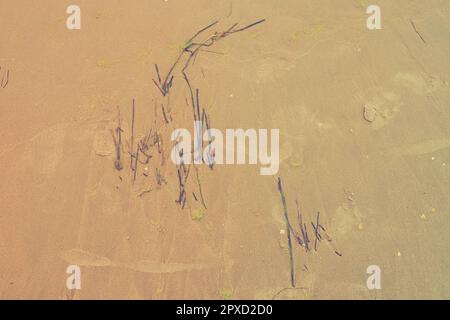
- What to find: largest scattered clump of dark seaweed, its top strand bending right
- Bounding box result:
[112,19,265,208]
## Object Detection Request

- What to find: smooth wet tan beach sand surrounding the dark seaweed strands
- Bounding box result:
[0,0,450,299]
